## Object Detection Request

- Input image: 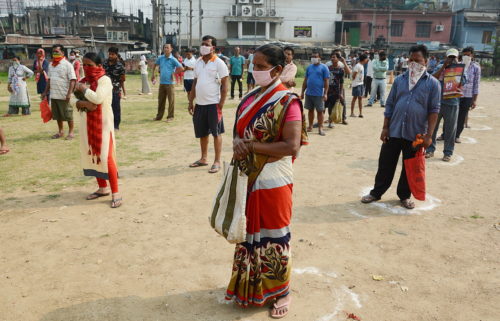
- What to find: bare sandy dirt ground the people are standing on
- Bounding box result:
[0,78,500,321]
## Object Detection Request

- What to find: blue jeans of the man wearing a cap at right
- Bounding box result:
[427,103,458,156]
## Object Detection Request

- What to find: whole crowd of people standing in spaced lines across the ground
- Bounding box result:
[0,36,481,318]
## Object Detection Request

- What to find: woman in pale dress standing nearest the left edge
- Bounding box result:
[5,57,33,116]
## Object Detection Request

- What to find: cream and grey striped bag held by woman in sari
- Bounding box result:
[210,160,248,244]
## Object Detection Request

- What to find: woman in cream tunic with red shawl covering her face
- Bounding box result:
[75,52,122,208]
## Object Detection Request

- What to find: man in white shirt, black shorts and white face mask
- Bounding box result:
[189,36,229,174]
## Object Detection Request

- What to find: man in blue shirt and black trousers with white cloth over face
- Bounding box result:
[361,45,441,209]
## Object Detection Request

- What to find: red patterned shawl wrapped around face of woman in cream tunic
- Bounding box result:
[80,67,106,164]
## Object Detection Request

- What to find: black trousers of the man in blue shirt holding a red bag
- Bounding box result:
[370,137,416,200]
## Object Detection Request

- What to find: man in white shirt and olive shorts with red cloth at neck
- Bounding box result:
[42,45,76,140]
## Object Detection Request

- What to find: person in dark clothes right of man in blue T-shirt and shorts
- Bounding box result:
[325,52,349,128]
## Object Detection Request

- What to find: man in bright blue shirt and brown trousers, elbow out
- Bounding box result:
[151,43,184,122]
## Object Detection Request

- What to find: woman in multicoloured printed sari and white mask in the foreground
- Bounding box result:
[226,45,307,318]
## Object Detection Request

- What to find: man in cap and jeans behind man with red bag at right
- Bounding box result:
[425,48,466,162]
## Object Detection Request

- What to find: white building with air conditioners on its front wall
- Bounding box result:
[165,0,342,46]
